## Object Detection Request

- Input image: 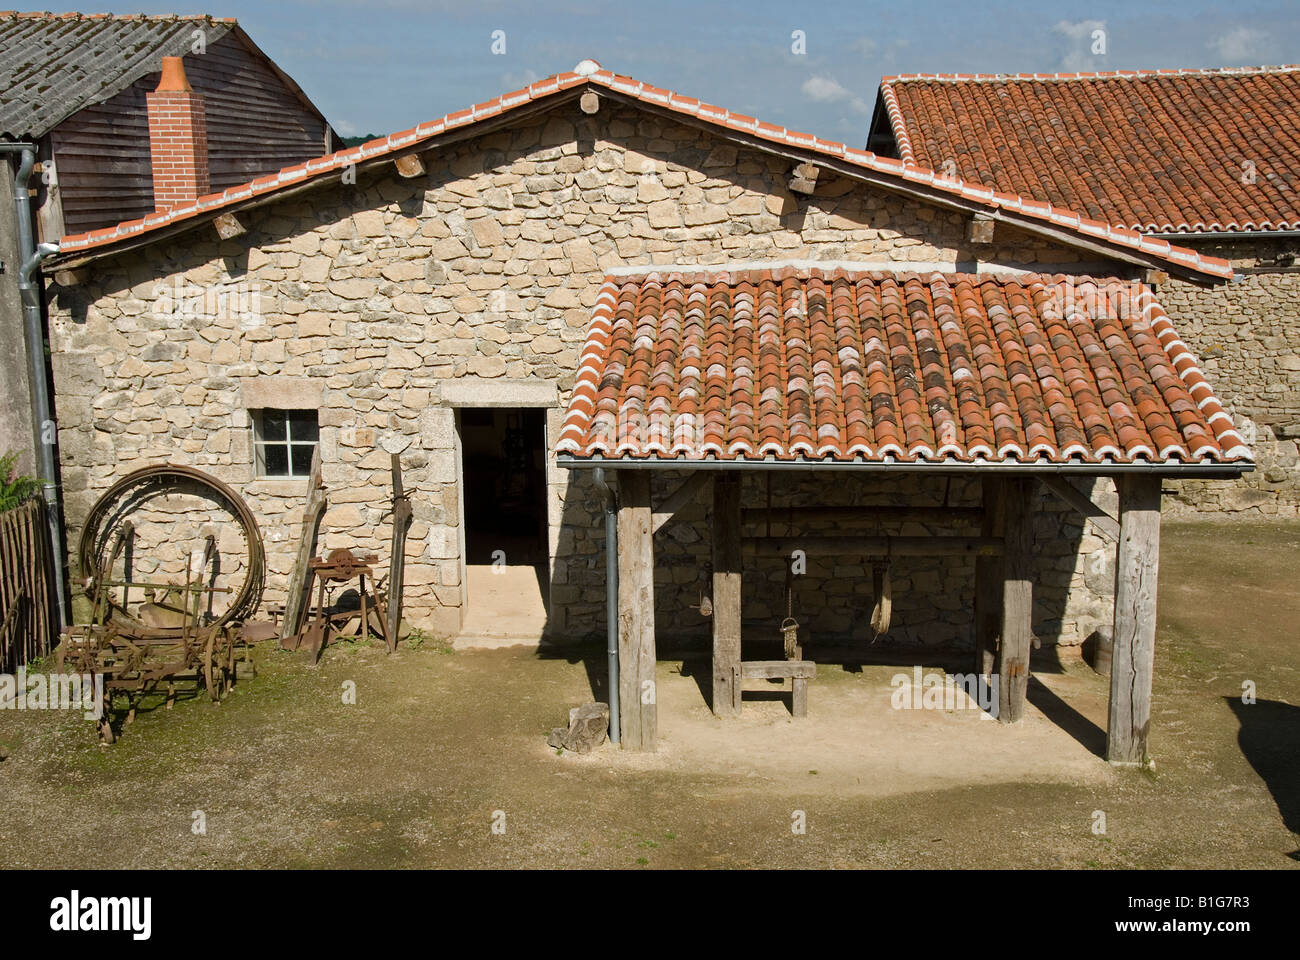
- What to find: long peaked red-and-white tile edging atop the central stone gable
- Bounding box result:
[48,60,1232,278]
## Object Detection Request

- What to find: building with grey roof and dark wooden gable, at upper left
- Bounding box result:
[0,10,338,473]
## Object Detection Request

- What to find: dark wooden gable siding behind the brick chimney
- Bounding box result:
[51,34,326,234]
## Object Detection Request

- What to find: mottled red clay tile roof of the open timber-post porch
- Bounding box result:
[556,268,1251,464]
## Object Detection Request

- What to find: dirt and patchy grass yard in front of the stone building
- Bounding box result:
[0,523,1300,869]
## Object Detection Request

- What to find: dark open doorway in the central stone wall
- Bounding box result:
[460,407,547,568]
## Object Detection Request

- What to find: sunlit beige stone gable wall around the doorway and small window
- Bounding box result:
[43,98,1159,641]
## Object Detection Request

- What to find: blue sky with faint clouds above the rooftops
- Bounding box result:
[124,0,1300,146]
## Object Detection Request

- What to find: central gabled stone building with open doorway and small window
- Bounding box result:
[38,61,1249,644]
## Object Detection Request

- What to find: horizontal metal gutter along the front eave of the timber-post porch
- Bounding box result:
[555,454,1255,480]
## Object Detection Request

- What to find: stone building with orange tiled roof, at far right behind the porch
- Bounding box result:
[867,66,1300,516]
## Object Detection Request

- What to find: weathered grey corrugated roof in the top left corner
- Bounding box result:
[0,10,235,139]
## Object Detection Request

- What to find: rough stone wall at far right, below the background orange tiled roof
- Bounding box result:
[1158,239,1300,516]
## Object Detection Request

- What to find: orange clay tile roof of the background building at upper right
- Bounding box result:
[880,66,1300,233]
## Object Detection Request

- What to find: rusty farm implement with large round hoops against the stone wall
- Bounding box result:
[55,466,265,743]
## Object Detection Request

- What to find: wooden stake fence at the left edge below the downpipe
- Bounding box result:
[0,500,59,674]
